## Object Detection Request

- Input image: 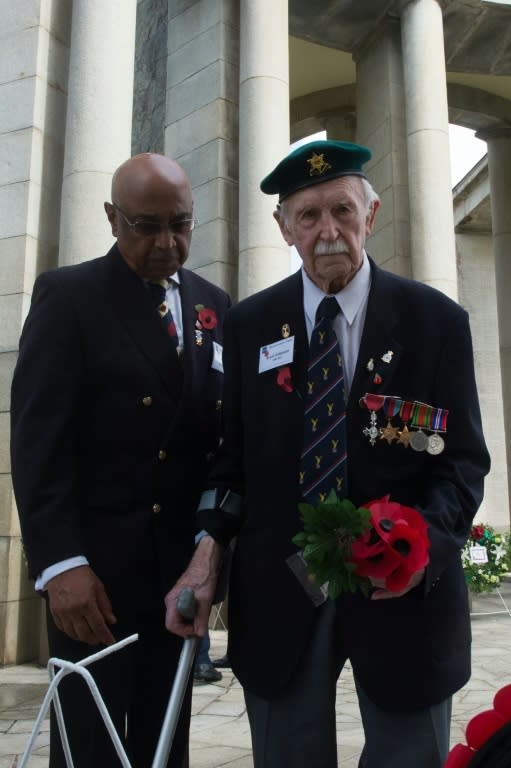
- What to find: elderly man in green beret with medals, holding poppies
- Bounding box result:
[166,141,489,768]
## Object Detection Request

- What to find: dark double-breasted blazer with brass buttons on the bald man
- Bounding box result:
[11,245,230,617]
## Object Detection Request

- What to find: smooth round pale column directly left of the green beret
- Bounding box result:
[238,0,289,299]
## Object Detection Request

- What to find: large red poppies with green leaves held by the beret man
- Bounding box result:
[293,490,429,599]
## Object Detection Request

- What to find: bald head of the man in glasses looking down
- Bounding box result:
[105,152,193,280]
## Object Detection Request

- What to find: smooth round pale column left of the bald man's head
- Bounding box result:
[59,0,136,265]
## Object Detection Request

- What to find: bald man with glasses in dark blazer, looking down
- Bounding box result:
[12,154,230,768]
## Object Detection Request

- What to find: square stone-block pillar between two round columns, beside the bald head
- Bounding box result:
[165,0,239,299]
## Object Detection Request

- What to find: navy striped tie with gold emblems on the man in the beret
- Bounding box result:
[299,296,347,504]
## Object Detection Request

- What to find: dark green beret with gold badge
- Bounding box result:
[261,141,371,201]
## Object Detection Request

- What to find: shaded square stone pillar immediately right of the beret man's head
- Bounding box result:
[354,19,412,277]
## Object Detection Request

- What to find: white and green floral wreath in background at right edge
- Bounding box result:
[461,523,511,593]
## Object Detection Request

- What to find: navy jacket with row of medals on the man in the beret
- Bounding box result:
[200,263,489,710]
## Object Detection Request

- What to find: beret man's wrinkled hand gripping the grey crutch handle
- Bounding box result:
[165,537,221,638]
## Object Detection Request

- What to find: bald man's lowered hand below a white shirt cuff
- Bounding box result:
[47,565,117,645]
